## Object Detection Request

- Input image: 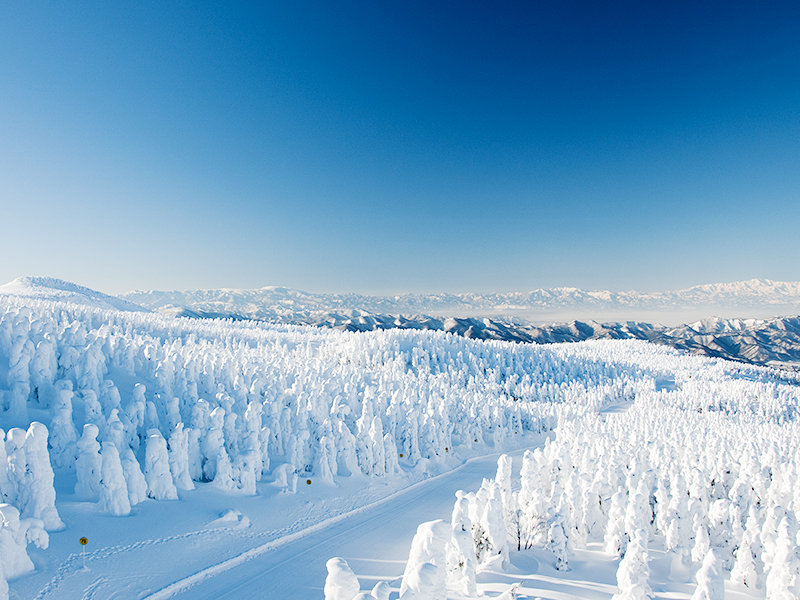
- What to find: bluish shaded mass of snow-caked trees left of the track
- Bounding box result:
[0,296,668,592]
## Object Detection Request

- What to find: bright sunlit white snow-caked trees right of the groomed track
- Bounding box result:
[331,357,800,600]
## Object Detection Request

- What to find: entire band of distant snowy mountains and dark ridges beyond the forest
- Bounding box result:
[0,277,800,371]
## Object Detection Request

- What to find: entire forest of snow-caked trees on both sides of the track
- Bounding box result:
[0,296,800,600]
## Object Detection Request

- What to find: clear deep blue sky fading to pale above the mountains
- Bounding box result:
[0,0,800,294]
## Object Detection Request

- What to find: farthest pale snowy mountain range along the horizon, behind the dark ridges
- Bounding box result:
[122,279,800,320]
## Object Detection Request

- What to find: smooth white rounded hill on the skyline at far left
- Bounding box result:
[0,277,147,311]
